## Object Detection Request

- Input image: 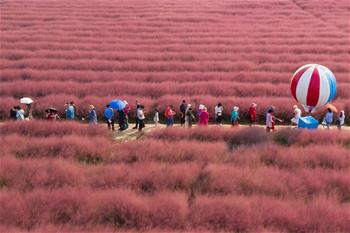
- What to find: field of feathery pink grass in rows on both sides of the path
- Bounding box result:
[0,0,350,232]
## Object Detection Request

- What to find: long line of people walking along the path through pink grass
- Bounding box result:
[10,100,345,132]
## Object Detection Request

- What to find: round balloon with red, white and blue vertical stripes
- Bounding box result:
[290,64,336,112]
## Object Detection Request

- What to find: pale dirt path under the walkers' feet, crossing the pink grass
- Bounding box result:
[113,124,350,142]
